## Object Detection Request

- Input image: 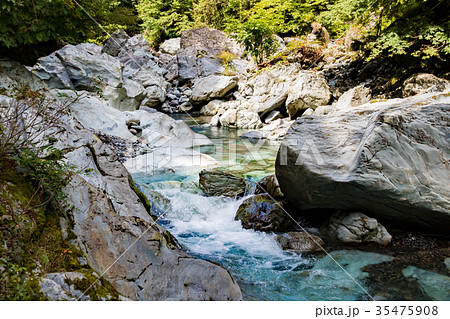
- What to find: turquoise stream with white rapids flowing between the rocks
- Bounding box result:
[135,117,449,300]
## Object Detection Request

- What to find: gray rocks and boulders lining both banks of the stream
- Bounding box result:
[0,29,450,300]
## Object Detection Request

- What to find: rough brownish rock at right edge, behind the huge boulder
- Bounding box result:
[402,73,450,97]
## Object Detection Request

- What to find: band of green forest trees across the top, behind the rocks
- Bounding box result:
[0,0,450,74]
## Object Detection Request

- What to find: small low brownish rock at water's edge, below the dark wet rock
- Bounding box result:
[275,232,325,253]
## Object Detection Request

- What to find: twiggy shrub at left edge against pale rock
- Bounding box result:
[0,86,81,204]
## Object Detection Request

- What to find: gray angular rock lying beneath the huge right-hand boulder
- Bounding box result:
[320,213,392,246]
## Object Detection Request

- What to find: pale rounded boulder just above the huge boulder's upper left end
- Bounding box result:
[286,71,331,117]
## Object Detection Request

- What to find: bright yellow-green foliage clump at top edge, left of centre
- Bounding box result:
[136,0,194,44]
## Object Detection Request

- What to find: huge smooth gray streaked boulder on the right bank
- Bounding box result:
[276,94,450,232]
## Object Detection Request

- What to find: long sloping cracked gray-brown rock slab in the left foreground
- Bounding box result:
[2,60,242,300]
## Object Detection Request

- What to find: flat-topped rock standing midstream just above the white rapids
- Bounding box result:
[199,169,247,197]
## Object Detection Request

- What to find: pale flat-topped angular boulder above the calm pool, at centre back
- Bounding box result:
[190,75,238,104]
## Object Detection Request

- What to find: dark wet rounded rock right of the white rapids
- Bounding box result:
[235,194,293,232]
